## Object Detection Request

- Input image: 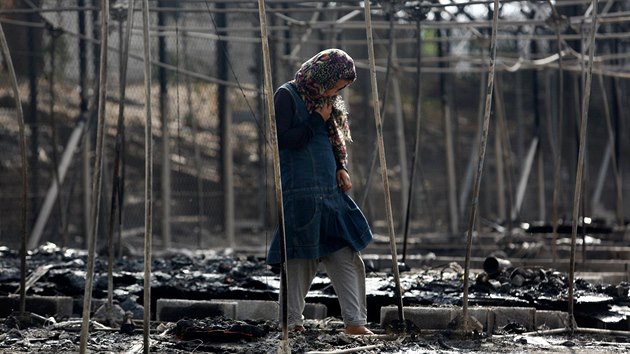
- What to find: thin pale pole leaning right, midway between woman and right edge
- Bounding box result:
[461,0,499,331]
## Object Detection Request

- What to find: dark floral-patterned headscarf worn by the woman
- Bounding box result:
[293,48,357,166]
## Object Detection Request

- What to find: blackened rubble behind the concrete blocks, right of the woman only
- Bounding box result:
[368,265,630,330]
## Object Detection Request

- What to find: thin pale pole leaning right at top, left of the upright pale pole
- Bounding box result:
[80,0,109,353]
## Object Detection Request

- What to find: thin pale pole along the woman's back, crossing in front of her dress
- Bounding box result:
[258,0,290,353]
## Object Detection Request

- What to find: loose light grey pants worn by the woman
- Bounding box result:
[280,247,367,328]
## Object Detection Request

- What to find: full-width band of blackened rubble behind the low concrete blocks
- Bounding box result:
[0,244,630,330]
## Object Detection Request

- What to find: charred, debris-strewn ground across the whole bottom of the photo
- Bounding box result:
[0,238,630,353]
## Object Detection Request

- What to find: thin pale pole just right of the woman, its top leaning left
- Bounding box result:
[365,1,405,324]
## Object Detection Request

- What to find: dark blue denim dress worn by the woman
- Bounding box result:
[267,83,372,264]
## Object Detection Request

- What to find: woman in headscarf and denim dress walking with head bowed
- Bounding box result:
[267,49,372,335]
